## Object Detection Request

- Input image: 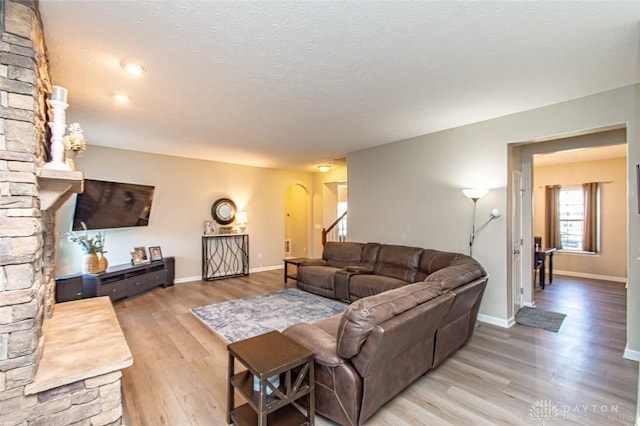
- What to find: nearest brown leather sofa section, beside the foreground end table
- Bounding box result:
[284,283,454,425]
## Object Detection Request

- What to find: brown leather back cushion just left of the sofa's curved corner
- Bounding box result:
[373,244,424,282]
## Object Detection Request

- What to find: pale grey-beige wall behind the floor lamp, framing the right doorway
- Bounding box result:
[347,85,640,355]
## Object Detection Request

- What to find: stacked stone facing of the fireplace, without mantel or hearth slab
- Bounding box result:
[0,0,122,426]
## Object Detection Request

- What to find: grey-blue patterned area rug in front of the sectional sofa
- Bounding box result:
[189,288,348,343]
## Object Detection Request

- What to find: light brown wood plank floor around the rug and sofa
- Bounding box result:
[114,270,638,426]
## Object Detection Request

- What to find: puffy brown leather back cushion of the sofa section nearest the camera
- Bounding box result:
[336,283,440,358]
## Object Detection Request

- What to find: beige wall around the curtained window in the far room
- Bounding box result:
[533,158,627,282]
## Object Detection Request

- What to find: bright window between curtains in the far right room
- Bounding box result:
[558,187,584,250]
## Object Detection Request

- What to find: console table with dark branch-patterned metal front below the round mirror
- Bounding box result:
[202,234,249,281]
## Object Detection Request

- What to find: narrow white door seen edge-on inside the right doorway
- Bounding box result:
[511,170,524,315]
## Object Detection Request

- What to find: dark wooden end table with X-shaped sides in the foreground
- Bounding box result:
[227,331,315,426]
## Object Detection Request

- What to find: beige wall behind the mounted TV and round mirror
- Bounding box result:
[56,146,313,280]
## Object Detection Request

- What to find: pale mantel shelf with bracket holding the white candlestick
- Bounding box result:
[37,169,84,211]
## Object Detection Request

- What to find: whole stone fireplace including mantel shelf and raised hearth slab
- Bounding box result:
[0,0,132,425]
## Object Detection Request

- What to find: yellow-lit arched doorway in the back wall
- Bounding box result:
[284,184,309,257]
